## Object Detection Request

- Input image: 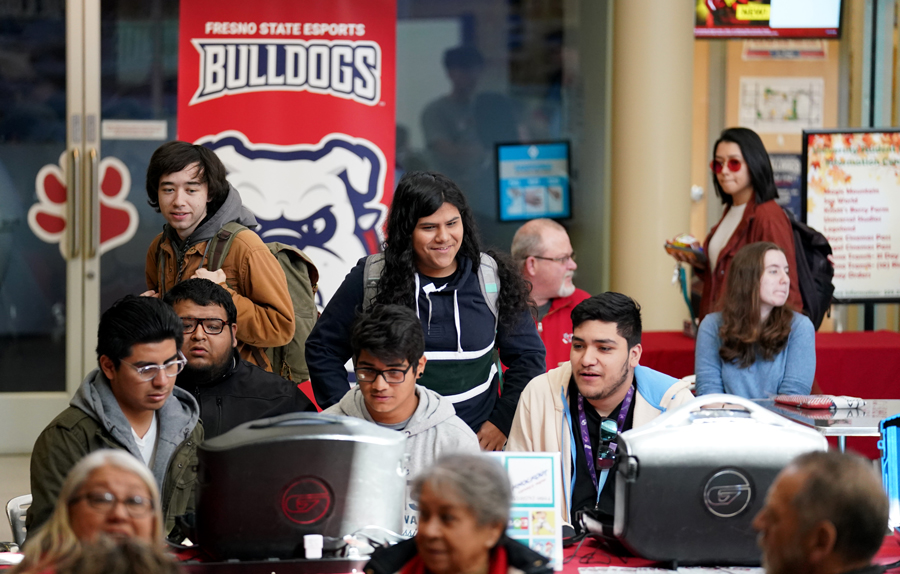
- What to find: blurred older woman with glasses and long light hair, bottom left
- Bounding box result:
[12,449,164,574]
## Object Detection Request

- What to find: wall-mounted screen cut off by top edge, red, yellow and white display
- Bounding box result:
[694,0,841,38]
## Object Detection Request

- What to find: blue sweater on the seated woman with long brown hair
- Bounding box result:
[694,312,816,399]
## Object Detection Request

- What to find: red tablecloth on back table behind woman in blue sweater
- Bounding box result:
[641,331,900,458]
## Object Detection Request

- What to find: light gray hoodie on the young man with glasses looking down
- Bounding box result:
[323,385,481,536]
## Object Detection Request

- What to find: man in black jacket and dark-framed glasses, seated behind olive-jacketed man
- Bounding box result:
[163,279,316,438]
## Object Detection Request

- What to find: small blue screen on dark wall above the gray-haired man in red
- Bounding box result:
[497,141,572,221]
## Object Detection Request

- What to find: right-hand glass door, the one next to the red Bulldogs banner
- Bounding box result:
[92,0,179,316]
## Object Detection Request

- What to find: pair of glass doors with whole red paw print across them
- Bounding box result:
[0,0,172,453]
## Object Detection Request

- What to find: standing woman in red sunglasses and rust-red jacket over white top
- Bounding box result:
[672,128,803,321]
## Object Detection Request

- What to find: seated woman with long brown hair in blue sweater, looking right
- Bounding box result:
[695,242,816,399]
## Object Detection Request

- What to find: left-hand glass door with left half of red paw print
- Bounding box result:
[0,0,89,452]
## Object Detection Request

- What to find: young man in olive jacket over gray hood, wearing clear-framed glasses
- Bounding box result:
[26,295,203,536]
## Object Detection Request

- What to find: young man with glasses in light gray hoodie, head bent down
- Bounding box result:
[325,305,481,536]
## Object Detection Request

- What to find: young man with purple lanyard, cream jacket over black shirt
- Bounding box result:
[506,292,693,526]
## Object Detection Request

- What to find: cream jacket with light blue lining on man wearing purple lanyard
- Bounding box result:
[505,363,694,522]
